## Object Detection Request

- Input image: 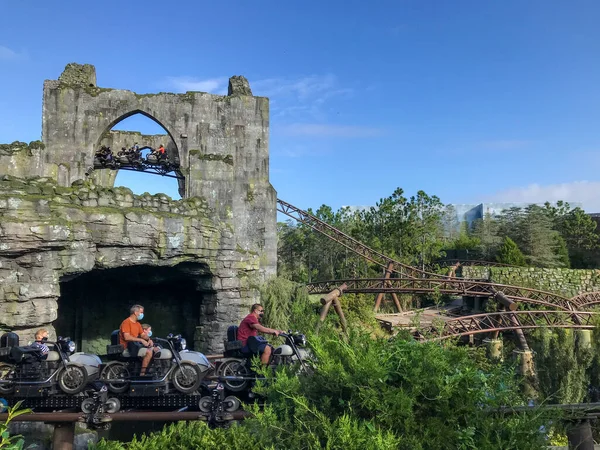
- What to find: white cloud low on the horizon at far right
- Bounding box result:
[488,181,600,212]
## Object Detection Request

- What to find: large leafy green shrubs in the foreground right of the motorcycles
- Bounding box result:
[96,279,546,450]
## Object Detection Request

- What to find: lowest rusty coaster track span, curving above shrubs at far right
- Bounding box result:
[424,311,598,341]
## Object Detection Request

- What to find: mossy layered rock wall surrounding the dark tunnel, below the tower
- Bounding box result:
[0,175,264,352]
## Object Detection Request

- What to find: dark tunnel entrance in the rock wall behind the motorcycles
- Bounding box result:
[53,263,212,355]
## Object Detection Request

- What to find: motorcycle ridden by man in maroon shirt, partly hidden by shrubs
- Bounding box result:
[217,325,313,392]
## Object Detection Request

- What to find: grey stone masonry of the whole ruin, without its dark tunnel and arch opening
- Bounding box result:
[0,63,277,306]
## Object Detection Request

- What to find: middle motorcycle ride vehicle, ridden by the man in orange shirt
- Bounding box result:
[100,330,213,396]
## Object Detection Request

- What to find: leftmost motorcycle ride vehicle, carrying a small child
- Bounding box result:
[0,333,101,397]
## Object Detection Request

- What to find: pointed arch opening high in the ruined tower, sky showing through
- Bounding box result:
[94,110,185,199]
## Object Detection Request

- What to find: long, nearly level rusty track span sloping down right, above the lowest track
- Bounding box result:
[306,278,576,311]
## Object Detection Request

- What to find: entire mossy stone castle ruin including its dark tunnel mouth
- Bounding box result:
[0,64,277,353]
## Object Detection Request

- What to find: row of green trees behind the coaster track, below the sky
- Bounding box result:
[278,189,600,282]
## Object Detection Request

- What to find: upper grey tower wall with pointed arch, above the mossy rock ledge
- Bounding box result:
[42,64,277,275]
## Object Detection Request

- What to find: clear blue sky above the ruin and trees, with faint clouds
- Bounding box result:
[0,0,600,211]
